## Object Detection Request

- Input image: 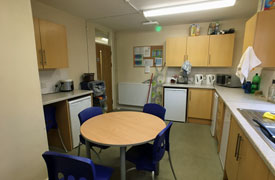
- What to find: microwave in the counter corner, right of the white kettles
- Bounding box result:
[216,74,242,88]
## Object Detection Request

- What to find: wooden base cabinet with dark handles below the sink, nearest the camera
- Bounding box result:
[225,117,270,180]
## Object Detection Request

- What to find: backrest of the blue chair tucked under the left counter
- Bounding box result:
[43,105,57,131]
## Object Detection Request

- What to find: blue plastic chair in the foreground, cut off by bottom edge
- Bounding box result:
[42,151,113,180]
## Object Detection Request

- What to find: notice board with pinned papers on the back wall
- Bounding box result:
[133,45,163,67]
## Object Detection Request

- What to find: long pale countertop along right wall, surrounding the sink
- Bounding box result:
[215,86,275,175]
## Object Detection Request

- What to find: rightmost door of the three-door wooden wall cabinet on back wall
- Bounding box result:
[208,34,235,67]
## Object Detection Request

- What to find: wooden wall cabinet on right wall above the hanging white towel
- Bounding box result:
[243,10,275,67]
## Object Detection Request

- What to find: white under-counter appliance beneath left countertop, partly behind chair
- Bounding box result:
[69,96,92,148]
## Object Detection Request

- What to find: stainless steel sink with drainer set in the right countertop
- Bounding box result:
[238,109,275,151]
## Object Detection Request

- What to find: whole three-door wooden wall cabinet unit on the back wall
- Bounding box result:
[166,34,235,67]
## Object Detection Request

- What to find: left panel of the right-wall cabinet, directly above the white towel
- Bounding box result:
[243,14,258,53]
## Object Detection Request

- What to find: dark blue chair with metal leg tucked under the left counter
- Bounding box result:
[43,105,68,152]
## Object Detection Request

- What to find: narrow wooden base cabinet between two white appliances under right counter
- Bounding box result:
[215,97,225,152]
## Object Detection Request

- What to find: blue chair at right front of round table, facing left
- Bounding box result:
[126,122,177,179]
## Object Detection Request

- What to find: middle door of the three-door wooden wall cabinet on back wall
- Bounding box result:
[187,36,209,67]
